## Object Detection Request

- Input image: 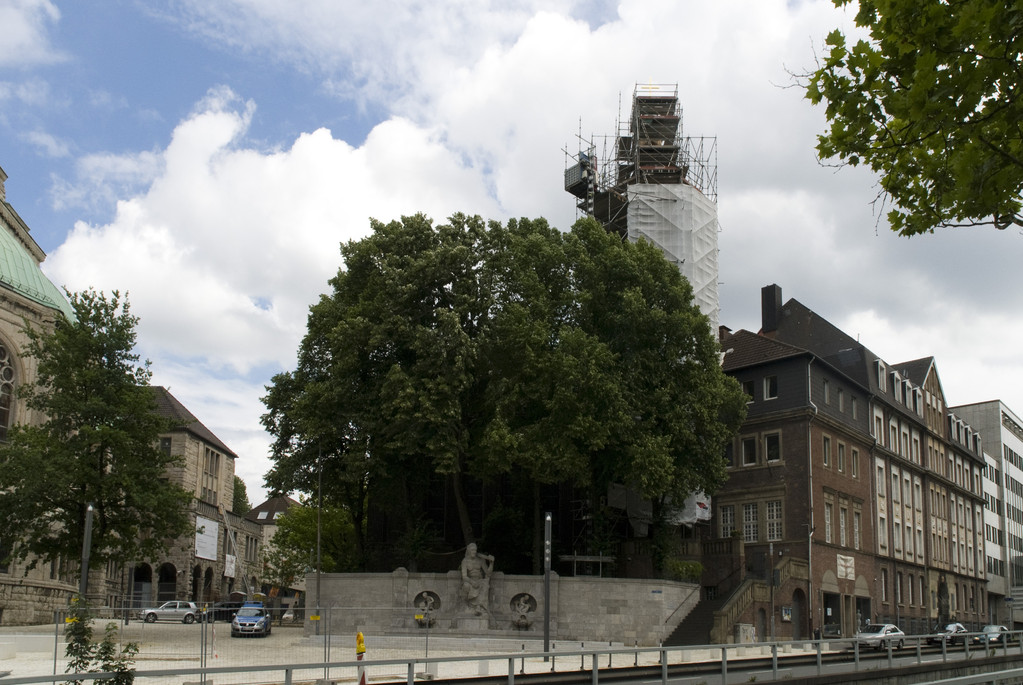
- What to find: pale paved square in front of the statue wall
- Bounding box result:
[0,621,671,685]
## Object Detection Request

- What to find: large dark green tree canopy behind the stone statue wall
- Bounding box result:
[263,215,745,568]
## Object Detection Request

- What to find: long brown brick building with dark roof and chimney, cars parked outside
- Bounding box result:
[688,285,987,642]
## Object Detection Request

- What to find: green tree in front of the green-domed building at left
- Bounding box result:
[0,290,189,562]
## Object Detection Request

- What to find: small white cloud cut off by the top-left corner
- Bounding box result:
[0,0,64,66]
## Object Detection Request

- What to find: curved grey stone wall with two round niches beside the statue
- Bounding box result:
[306,568,700,646]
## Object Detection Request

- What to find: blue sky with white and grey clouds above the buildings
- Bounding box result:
[0,0,1023,504]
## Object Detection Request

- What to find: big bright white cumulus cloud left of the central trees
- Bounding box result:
[44,90,507,500]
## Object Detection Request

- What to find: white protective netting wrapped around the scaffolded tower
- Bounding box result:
[628,184,719,335]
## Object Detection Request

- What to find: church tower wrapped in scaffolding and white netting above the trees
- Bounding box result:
[565,85,719,334]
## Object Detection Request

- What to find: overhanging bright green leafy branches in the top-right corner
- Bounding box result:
[806,0,1023,236]
